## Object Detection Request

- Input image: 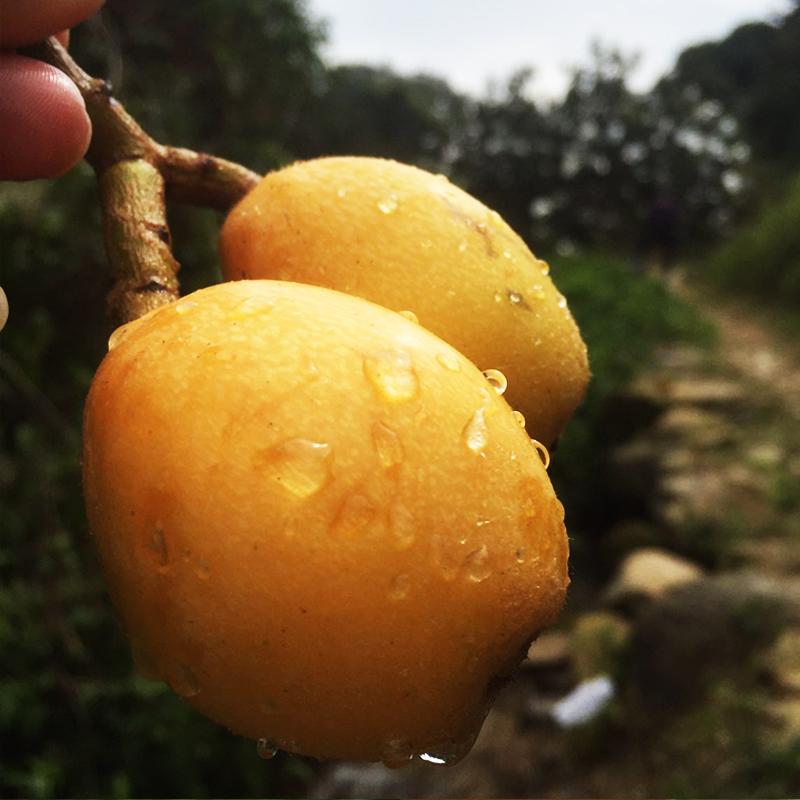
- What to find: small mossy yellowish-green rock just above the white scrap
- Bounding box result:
[572,611,631,680]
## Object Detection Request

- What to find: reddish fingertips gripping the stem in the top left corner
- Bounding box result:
[0,0,105,181]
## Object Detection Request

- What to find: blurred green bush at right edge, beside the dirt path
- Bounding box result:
[703,174,800,308]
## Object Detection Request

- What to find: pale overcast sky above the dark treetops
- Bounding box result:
[308,0,791,97]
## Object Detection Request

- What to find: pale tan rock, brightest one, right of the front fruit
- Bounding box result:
[604,547,703,607]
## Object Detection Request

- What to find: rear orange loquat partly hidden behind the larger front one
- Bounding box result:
[220,157,589,445]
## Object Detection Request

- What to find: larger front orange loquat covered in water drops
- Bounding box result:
[83,281,568,764]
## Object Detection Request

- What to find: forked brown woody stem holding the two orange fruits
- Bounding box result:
[23,37,259,324]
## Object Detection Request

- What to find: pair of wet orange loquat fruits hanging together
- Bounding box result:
[84,158,588,766]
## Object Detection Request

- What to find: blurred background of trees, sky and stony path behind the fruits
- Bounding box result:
[0,0,800,797]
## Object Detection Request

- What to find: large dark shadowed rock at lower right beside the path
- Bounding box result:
[629,574,800,709]
